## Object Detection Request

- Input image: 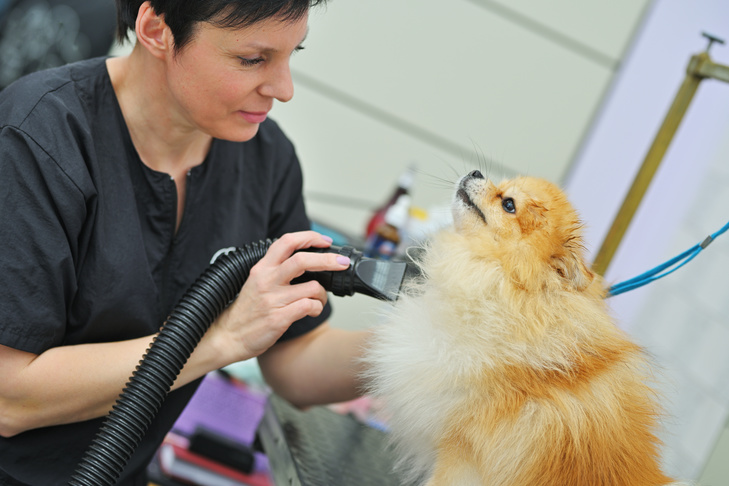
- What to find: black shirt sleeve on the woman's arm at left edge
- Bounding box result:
[0,127,85,354]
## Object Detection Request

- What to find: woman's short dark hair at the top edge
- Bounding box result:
[116,0,326,51]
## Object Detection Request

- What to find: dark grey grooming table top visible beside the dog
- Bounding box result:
[258,395,416,486]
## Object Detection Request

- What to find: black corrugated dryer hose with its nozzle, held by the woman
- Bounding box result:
[69,240,415,486]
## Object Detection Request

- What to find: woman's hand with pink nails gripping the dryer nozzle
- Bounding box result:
[207,231,349,364]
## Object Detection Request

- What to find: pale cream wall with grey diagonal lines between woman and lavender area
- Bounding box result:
[272,0,646,237]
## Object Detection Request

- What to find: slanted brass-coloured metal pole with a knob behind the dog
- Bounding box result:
[592,36,727,275]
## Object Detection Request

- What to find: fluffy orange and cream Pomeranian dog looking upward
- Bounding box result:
[365,171,672,486]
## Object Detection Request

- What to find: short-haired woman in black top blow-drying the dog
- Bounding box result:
[0,0,367,486]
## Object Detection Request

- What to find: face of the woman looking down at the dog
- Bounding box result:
[166,16,308,142]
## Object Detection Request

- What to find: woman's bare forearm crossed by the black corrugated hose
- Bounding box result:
[0,330,227,437]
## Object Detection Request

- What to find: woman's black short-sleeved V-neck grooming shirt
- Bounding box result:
[0,59,330,486]
